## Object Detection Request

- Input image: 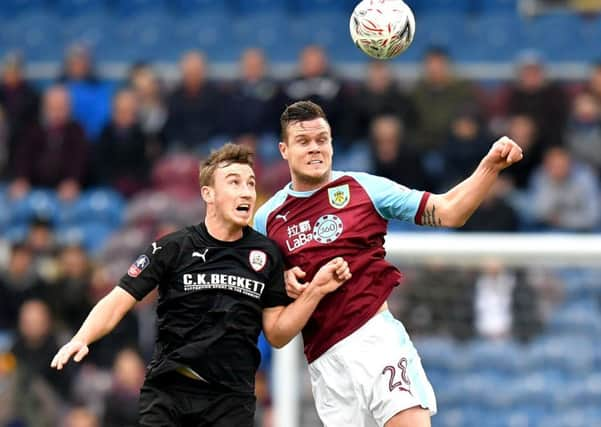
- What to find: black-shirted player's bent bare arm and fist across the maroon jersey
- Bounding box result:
[263,258,351,348]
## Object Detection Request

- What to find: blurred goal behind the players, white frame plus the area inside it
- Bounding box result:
[265,232,601,427]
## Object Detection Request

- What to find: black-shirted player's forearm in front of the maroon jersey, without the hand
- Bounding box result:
[265,285,323,348]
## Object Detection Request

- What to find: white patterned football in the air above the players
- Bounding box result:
[349,0,415,59]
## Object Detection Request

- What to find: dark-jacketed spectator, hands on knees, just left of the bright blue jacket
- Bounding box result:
[11,86,88,200]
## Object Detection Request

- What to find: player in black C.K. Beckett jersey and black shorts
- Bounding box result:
[51,144,351,427]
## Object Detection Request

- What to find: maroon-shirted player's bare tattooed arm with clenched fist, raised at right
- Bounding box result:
[416,137,523,227]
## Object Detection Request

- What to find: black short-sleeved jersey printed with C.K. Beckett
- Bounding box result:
[119,223,290,392]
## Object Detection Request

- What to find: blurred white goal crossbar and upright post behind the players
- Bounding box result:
[273,231,601,427]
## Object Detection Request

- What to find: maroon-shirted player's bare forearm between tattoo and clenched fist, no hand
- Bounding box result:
[441,162,499,227]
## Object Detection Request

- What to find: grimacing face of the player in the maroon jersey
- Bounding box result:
[280,118,334,191]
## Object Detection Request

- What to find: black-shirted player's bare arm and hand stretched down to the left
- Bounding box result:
[50,286,136,370]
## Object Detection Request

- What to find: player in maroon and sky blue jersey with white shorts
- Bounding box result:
[254,101,522,427]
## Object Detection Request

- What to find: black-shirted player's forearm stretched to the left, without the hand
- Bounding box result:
[71,289,133,345]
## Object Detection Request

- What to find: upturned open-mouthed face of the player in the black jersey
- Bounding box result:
[205,163,257,227]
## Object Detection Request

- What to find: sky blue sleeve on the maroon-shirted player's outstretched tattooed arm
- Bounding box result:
[349,172,424,223]
